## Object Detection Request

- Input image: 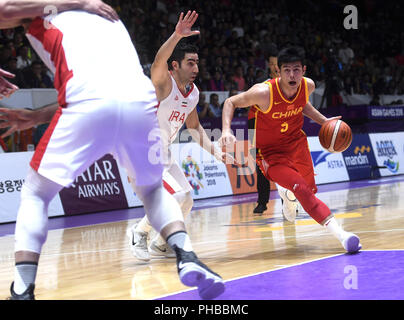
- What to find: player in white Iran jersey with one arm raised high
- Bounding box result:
[127,11,232,261]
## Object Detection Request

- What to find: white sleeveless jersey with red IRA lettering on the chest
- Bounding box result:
[157,75,199,144]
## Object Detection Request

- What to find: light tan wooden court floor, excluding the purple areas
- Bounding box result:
[0,179,404,300]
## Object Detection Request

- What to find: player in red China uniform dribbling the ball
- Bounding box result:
[219,47,361,253]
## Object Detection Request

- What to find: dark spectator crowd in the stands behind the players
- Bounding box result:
[0,0,404,106]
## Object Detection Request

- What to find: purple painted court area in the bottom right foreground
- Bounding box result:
[159,250,404,300]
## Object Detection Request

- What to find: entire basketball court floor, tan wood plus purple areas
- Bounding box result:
[0,176,404,300]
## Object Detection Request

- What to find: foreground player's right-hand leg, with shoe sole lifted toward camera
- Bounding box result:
[114,99,224,298]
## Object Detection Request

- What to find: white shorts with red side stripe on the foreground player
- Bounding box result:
[31,95,163,187]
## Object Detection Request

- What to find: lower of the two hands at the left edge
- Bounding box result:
[0,108,37,138]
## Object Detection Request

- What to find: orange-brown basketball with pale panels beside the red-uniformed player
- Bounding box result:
[318,120,352,152]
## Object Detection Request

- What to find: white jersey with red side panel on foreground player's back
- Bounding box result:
[26,11,155,106]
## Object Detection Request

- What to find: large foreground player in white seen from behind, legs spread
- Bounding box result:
[0,0,224,300]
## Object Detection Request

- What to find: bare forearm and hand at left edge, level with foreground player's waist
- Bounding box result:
[0,104,59,138]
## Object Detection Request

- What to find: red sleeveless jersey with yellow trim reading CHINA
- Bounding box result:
[250,78,309,154]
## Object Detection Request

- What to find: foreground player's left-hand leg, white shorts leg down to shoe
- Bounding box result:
[11,101,115,299]
